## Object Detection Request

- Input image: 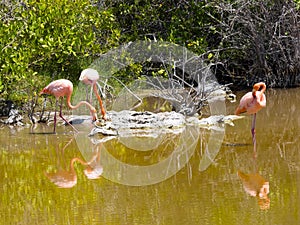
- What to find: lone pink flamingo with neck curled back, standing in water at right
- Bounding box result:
[235,82,267,157]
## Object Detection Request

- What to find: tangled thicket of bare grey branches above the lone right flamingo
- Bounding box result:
[210,0,300,87]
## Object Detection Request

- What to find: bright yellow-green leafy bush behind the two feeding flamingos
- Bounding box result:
[0,0,119,100]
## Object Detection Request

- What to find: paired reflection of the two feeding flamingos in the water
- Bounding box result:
[45,144,103,188]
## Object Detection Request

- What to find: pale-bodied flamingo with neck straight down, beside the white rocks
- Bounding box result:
[79,68,107,120]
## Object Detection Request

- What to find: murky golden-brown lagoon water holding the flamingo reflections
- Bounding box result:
[0,89,300,224]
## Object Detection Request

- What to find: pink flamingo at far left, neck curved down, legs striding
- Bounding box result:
[40,79,97,133]
